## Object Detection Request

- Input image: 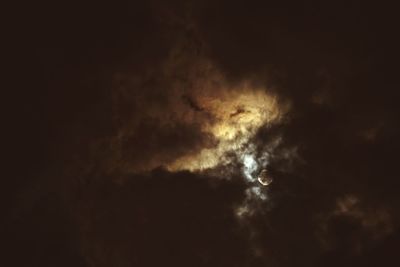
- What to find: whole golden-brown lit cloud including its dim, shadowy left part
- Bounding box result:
[111,44,288,181]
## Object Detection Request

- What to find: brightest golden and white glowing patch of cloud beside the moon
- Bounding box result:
[166,86,282,174]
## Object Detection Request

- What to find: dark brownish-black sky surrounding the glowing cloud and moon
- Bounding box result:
[0,0,400,267]
